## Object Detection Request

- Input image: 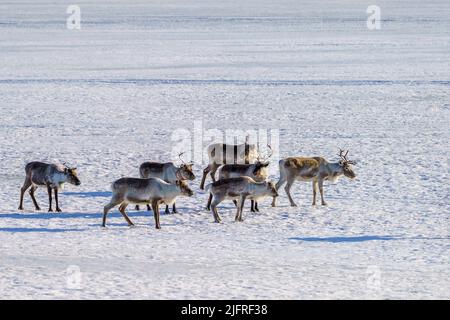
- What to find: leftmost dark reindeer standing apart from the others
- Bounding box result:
[19,161,81,212]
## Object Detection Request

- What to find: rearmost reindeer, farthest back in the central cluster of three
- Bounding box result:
[200,136,258,190]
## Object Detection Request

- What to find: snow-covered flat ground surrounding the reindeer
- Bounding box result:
[0,0,450,299]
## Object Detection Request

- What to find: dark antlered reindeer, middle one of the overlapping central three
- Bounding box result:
[206,145,273,212]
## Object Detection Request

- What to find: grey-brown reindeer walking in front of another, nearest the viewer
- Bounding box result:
[102,178,194,229]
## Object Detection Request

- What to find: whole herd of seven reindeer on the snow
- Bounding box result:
[19,140,356,229]
